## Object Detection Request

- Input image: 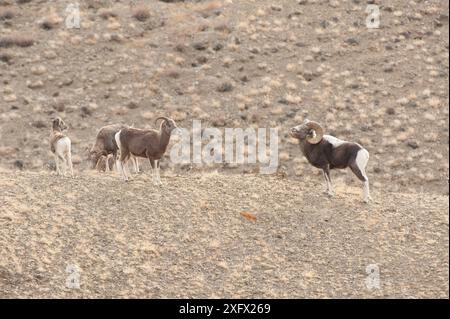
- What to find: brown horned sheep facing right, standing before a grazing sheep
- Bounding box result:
[115,116,178,185]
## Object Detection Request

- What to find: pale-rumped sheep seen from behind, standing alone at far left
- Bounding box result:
[50,117,73,178]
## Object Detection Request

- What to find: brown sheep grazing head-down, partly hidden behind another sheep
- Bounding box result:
[89,124,139,173]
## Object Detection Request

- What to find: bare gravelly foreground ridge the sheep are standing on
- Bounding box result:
[0,172,449,298]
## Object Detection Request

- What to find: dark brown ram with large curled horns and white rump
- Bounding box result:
[290,120,372,203]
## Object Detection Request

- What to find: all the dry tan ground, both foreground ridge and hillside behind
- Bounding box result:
[0,0,449,298]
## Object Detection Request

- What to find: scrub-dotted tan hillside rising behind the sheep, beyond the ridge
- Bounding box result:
[0,0,449,194]
